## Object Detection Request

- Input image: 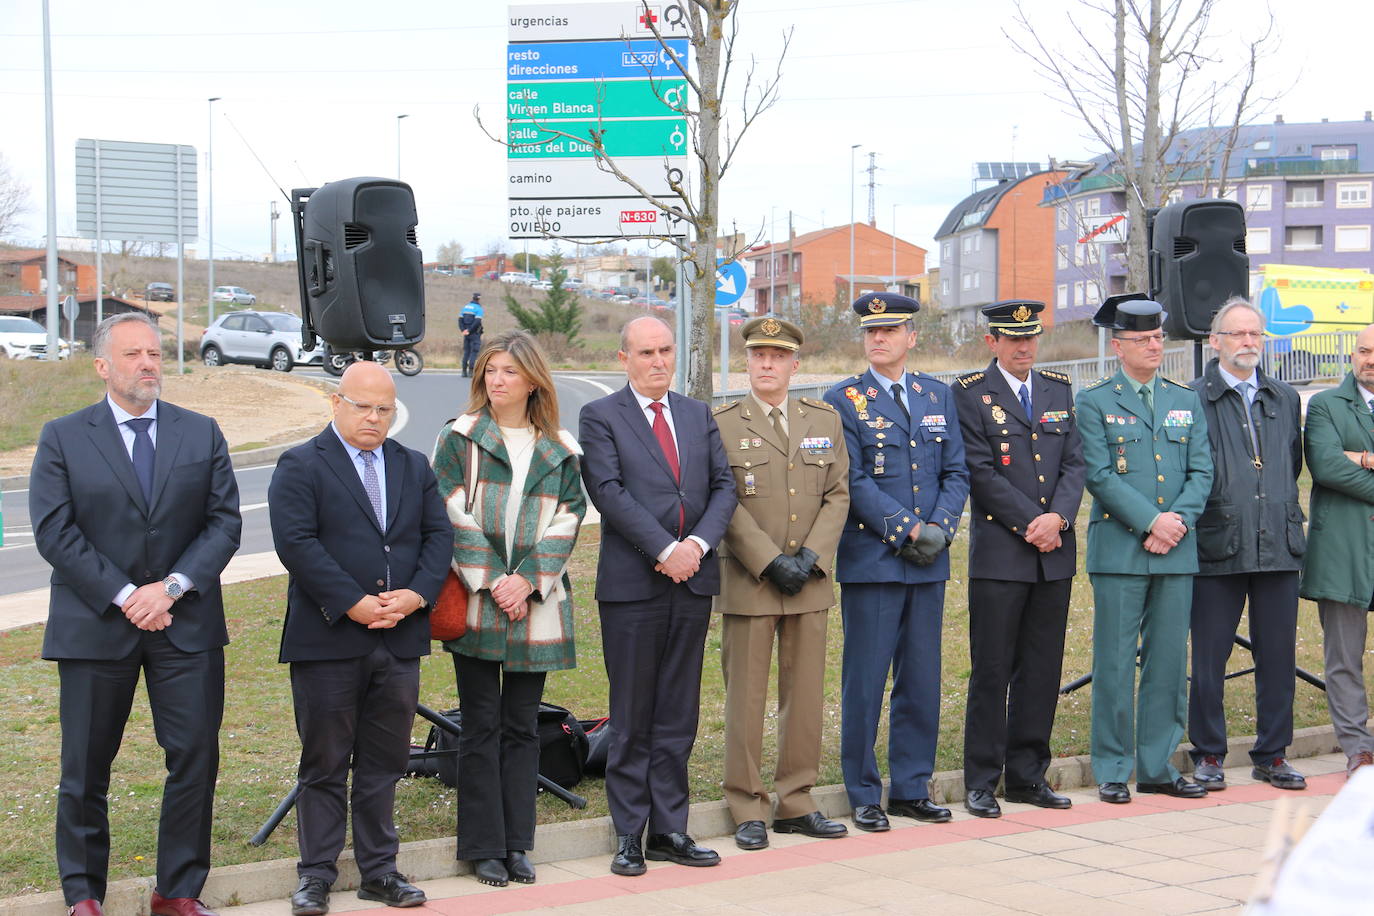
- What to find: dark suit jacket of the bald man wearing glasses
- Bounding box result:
[268,426,453,662]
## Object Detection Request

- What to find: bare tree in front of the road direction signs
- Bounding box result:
[474,0,791,400]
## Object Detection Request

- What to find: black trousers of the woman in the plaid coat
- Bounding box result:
[453,652,544,860]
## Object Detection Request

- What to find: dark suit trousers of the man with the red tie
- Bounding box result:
[599,584,710,835]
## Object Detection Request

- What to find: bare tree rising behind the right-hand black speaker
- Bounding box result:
[1006,0,1276,290]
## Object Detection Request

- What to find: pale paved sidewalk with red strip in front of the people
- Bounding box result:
[218,754,1345,916]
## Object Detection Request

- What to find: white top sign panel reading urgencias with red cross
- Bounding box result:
[508,0,691,43]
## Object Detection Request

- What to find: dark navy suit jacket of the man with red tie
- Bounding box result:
[577,385,736,602]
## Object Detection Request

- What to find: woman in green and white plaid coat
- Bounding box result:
[434,331,587,887]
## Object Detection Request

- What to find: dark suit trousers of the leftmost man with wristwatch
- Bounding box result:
[56,631,224,905]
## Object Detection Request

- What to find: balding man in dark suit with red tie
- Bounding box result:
[578,317,736,875]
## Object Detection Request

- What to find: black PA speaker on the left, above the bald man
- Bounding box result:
[291,179,425,350]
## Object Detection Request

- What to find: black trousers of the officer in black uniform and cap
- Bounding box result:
[963,578,1073,791]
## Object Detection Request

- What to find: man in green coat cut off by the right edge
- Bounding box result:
[1300,324,1374,773]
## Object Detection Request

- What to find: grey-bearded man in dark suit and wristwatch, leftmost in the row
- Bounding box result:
[29,313,242,916]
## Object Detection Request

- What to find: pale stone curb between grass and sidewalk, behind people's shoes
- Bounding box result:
[0,725,1340,916]
